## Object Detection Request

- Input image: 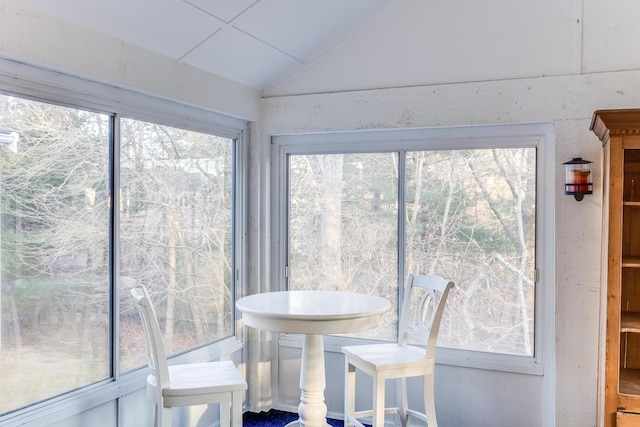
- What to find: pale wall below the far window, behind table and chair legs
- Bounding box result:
[276,345,544,427]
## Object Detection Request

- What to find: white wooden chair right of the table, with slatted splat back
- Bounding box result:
[342,274,453,427]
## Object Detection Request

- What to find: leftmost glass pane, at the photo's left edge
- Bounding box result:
[0,95,110,412]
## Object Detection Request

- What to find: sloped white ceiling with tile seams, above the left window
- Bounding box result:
[13,0,393,89]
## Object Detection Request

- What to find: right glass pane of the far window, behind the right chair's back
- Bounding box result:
[407,148,536,356]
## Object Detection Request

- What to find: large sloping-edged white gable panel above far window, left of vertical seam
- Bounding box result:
[264,0,581,96]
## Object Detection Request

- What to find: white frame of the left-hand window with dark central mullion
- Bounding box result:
[0,58,249,425]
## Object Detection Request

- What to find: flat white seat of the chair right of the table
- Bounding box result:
[342,343,433,375]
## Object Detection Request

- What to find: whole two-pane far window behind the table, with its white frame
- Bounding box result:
[273,125,552,368]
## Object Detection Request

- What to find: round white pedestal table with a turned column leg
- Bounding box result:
[236,291,391,427]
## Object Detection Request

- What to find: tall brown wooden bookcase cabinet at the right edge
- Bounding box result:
[591,109,640,427]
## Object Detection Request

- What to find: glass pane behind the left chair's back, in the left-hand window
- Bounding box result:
[119,119,235,370]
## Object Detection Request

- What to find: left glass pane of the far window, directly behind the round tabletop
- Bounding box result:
[289,153,398,340]
